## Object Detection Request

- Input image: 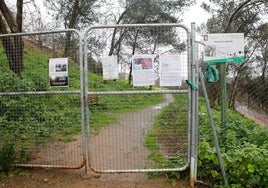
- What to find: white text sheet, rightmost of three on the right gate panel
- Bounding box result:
[159,55,182,86]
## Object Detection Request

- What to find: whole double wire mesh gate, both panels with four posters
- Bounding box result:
[0,24,197,177]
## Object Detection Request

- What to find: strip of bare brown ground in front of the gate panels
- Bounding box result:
[0,169,189,188]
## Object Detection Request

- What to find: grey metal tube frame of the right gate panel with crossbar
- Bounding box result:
[83,23,192,173]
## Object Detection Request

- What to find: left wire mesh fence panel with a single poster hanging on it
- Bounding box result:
[0,30,84,168]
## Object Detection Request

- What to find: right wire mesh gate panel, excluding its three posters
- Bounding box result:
[84,24,191,172]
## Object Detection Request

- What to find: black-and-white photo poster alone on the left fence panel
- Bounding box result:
[49,58,68,87]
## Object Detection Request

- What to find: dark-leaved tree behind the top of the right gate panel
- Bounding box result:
[103,0,193,83]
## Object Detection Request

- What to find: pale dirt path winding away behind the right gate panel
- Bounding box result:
[89,94,174,171]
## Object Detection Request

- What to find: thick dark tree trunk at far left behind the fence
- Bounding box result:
[0,0,23,74]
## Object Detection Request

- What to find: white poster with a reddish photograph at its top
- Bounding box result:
[132,55,154,86]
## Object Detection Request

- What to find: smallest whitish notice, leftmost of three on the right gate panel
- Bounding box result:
[101,56,119,80]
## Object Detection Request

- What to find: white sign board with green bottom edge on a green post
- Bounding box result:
[204,33,245,63]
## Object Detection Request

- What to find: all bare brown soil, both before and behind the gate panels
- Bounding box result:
[0,95,193,188]
